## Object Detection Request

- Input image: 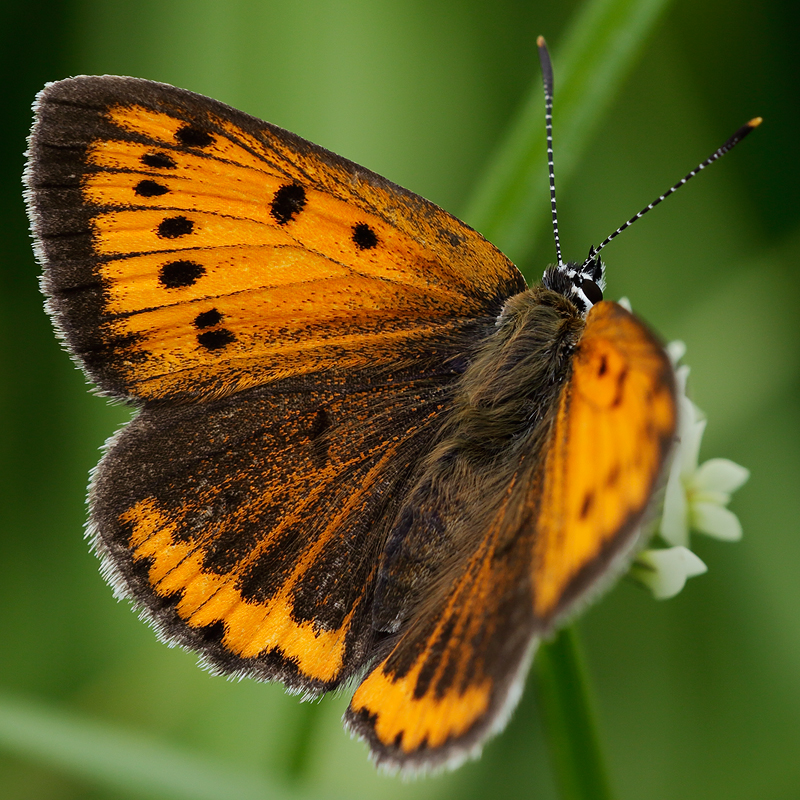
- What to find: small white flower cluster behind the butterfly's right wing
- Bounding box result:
[630,342,750,599]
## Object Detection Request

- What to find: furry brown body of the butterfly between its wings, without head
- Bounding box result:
[373,287,584,631]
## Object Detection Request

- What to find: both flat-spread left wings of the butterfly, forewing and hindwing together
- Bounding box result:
[25,77,525,692]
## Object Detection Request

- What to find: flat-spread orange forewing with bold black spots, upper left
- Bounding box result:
[26,77,525,400]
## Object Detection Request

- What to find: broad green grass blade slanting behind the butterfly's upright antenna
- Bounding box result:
[464,0,670,262]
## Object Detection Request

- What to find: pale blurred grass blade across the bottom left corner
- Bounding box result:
[0,695,328,800]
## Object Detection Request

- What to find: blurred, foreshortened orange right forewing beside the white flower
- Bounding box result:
[533,302,676,620]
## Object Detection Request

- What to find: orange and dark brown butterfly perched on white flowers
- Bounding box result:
[20,42,756,771]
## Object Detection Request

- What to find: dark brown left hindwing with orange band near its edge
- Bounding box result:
[90,366,468,693]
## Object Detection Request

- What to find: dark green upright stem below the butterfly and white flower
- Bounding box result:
[536,626,612,800]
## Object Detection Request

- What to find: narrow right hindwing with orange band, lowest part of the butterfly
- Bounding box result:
[346,475,535,772]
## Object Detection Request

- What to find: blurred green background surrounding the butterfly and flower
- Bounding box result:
[0,0,800,800]
